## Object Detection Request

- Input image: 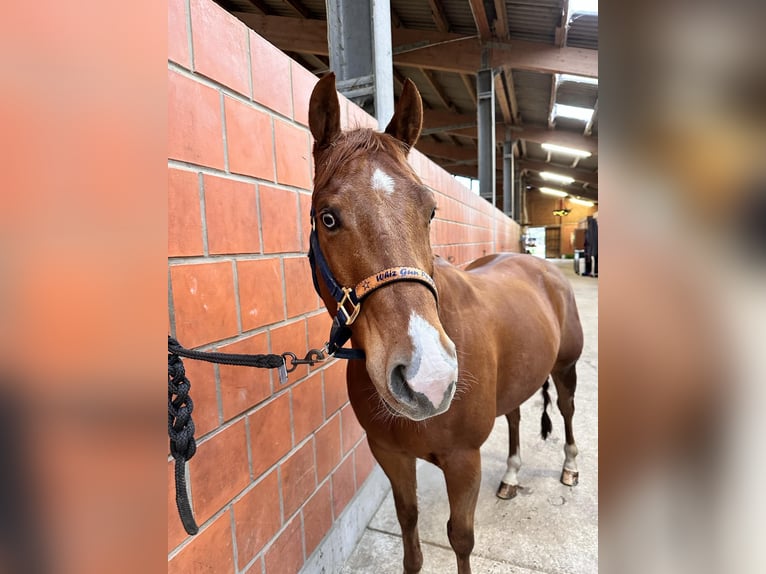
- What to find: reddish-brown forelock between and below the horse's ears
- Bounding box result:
[314,128,414,188]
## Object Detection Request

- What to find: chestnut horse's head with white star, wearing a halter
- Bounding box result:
[309,74,458,420]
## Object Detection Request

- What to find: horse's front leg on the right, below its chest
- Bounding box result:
[441,449,481,574]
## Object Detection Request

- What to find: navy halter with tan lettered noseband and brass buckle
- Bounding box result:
[308,207,439,359]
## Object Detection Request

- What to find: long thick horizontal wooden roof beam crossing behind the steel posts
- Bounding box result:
[234,12,598,78]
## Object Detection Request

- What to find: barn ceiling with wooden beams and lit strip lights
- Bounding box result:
[216,0,598,204]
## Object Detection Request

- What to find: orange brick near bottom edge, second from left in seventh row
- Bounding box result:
[234,471,282,568]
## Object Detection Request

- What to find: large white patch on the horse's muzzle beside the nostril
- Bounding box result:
[404,311,458,408]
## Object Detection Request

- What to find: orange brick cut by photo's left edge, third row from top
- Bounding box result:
[168,169,203,257]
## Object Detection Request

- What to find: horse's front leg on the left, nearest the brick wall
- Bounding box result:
[368,441,423,574]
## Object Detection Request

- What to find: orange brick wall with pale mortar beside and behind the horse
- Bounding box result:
[167,0,519,574]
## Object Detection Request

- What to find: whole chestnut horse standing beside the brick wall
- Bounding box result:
[309,74,583,574]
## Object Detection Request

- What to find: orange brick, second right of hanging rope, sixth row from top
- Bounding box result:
[248,394,292,477]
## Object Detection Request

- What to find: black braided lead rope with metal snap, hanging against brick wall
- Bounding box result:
[168,335,354,535]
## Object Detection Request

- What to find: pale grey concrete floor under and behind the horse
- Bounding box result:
[341,260,598,574]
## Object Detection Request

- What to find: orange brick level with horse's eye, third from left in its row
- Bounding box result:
[259,185,301,253]
